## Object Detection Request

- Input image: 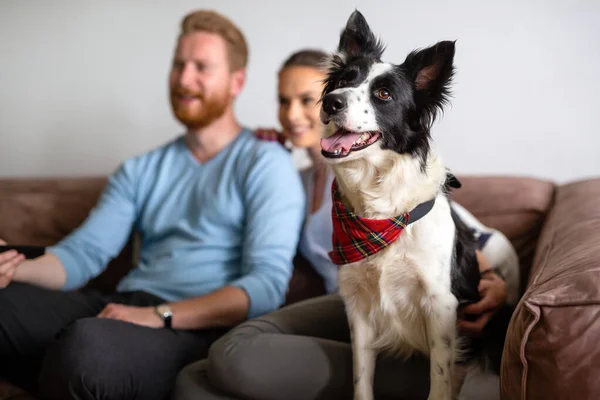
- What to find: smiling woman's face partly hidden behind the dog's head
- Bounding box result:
[279,66,325,147]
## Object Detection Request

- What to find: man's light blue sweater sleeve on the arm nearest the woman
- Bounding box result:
[231,143,306,318]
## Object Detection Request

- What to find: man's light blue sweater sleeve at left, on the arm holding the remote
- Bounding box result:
[48,159,136,290]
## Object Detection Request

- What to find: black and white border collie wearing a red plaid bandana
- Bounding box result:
[321,11,515,400]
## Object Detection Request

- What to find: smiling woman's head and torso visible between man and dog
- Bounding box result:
[257,49,337,292]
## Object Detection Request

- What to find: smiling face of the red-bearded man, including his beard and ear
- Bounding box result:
[169,32,243,129]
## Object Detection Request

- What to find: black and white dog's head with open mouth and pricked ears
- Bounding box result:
[321,11,455,163]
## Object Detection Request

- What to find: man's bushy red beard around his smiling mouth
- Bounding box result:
[170,88,231,129]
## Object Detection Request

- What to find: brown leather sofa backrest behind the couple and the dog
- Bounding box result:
[0,177,555,303]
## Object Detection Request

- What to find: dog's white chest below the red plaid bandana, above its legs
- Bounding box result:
[339,195,456,356]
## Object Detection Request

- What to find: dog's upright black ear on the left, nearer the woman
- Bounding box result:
[338,10,385,60]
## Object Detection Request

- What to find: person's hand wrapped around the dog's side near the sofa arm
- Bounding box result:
[458,272,507,337]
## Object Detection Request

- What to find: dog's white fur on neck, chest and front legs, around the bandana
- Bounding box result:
[334,146,459,400]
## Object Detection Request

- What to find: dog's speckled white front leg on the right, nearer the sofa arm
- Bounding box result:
[427,293,457,400]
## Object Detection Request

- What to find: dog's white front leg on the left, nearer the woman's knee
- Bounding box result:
[348,311,376,400]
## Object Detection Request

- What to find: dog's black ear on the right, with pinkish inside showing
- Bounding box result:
[401,41,456,125]
